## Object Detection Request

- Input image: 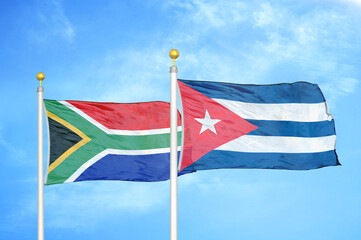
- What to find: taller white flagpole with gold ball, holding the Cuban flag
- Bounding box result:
[169,49,179,240]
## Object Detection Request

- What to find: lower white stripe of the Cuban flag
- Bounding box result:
[216,135,336,153]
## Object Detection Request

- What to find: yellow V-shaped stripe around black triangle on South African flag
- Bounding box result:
[46,111,91,174]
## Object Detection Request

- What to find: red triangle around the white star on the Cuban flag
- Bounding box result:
[178,81,257,170]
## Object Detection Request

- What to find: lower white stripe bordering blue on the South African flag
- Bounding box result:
[65,146,181,182]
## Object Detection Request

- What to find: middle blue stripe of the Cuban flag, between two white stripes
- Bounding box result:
[246,119,336,137]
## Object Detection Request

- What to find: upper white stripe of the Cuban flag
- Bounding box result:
[213,99,332,122]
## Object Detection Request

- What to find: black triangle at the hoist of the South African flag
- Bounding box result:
[48,118,82,165]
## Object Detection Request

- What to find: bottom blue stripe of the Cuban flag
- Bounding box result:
[184,150,340,171]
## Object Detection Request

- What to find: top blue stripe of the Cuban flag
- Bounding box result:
[179,79,325,103]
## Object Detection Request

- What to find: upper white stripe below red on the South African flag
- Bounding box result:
[58,101,182,136]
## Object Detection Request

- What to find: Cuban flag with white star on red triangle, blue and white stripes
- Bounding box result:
[178,80,339,171]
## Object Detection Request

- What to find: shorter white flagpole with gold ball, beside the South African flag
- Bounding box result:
[36,72,45,240]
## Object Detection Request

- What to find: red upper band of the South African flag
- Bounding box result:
[67,101,181,130]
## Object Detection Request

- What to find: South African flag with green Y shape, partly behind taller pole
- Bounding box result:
[44,100,181,185]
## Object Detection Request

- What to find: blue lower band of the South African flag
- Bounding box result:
[75,152,190,182]
